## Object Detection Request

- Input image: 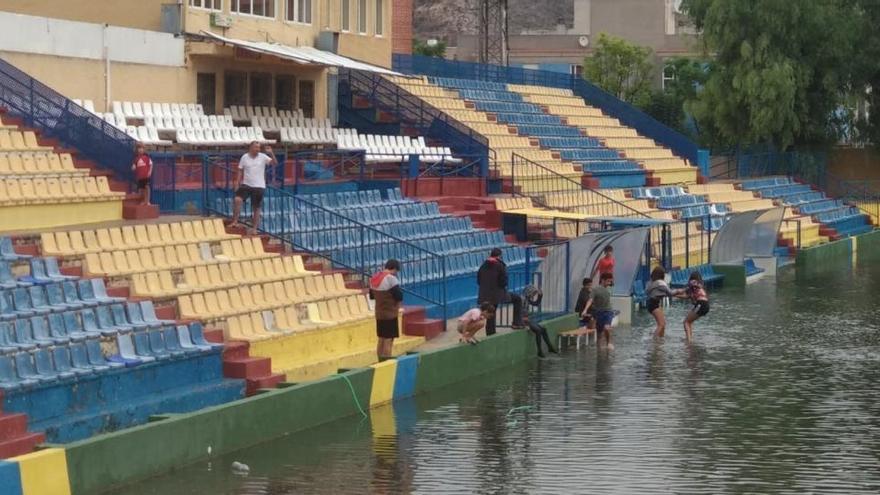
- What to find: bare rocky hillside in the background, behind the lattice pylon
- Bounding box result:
[414,0,574,45]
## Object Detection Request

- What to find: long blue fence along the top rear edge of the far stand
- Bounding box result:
[393,54,709,174]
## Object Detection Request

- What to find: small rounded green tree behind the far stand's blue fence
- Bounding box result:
[584,33,654,106]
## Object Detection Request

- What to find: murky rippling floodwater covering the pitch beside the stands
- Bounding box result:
[106,255,880,495]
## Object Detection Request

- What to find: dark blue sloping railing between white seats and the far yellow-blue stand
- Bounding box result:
[339,69,490,177]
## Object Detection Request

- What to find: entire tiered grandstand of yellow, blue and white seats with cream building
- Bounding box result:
[0,0,876,476]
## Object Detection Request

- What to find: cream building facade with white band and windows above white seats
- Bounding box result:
[0,0,393,117]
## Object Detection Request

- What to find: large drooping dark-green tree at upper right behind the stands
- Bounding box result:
[682,0,864,148]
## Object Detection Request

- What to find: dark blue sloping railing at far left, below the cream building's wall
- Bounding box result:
[0,59,134,180]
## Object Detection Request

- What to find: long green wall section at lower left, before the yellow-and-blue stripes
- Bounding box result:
[65,369,373,494]
